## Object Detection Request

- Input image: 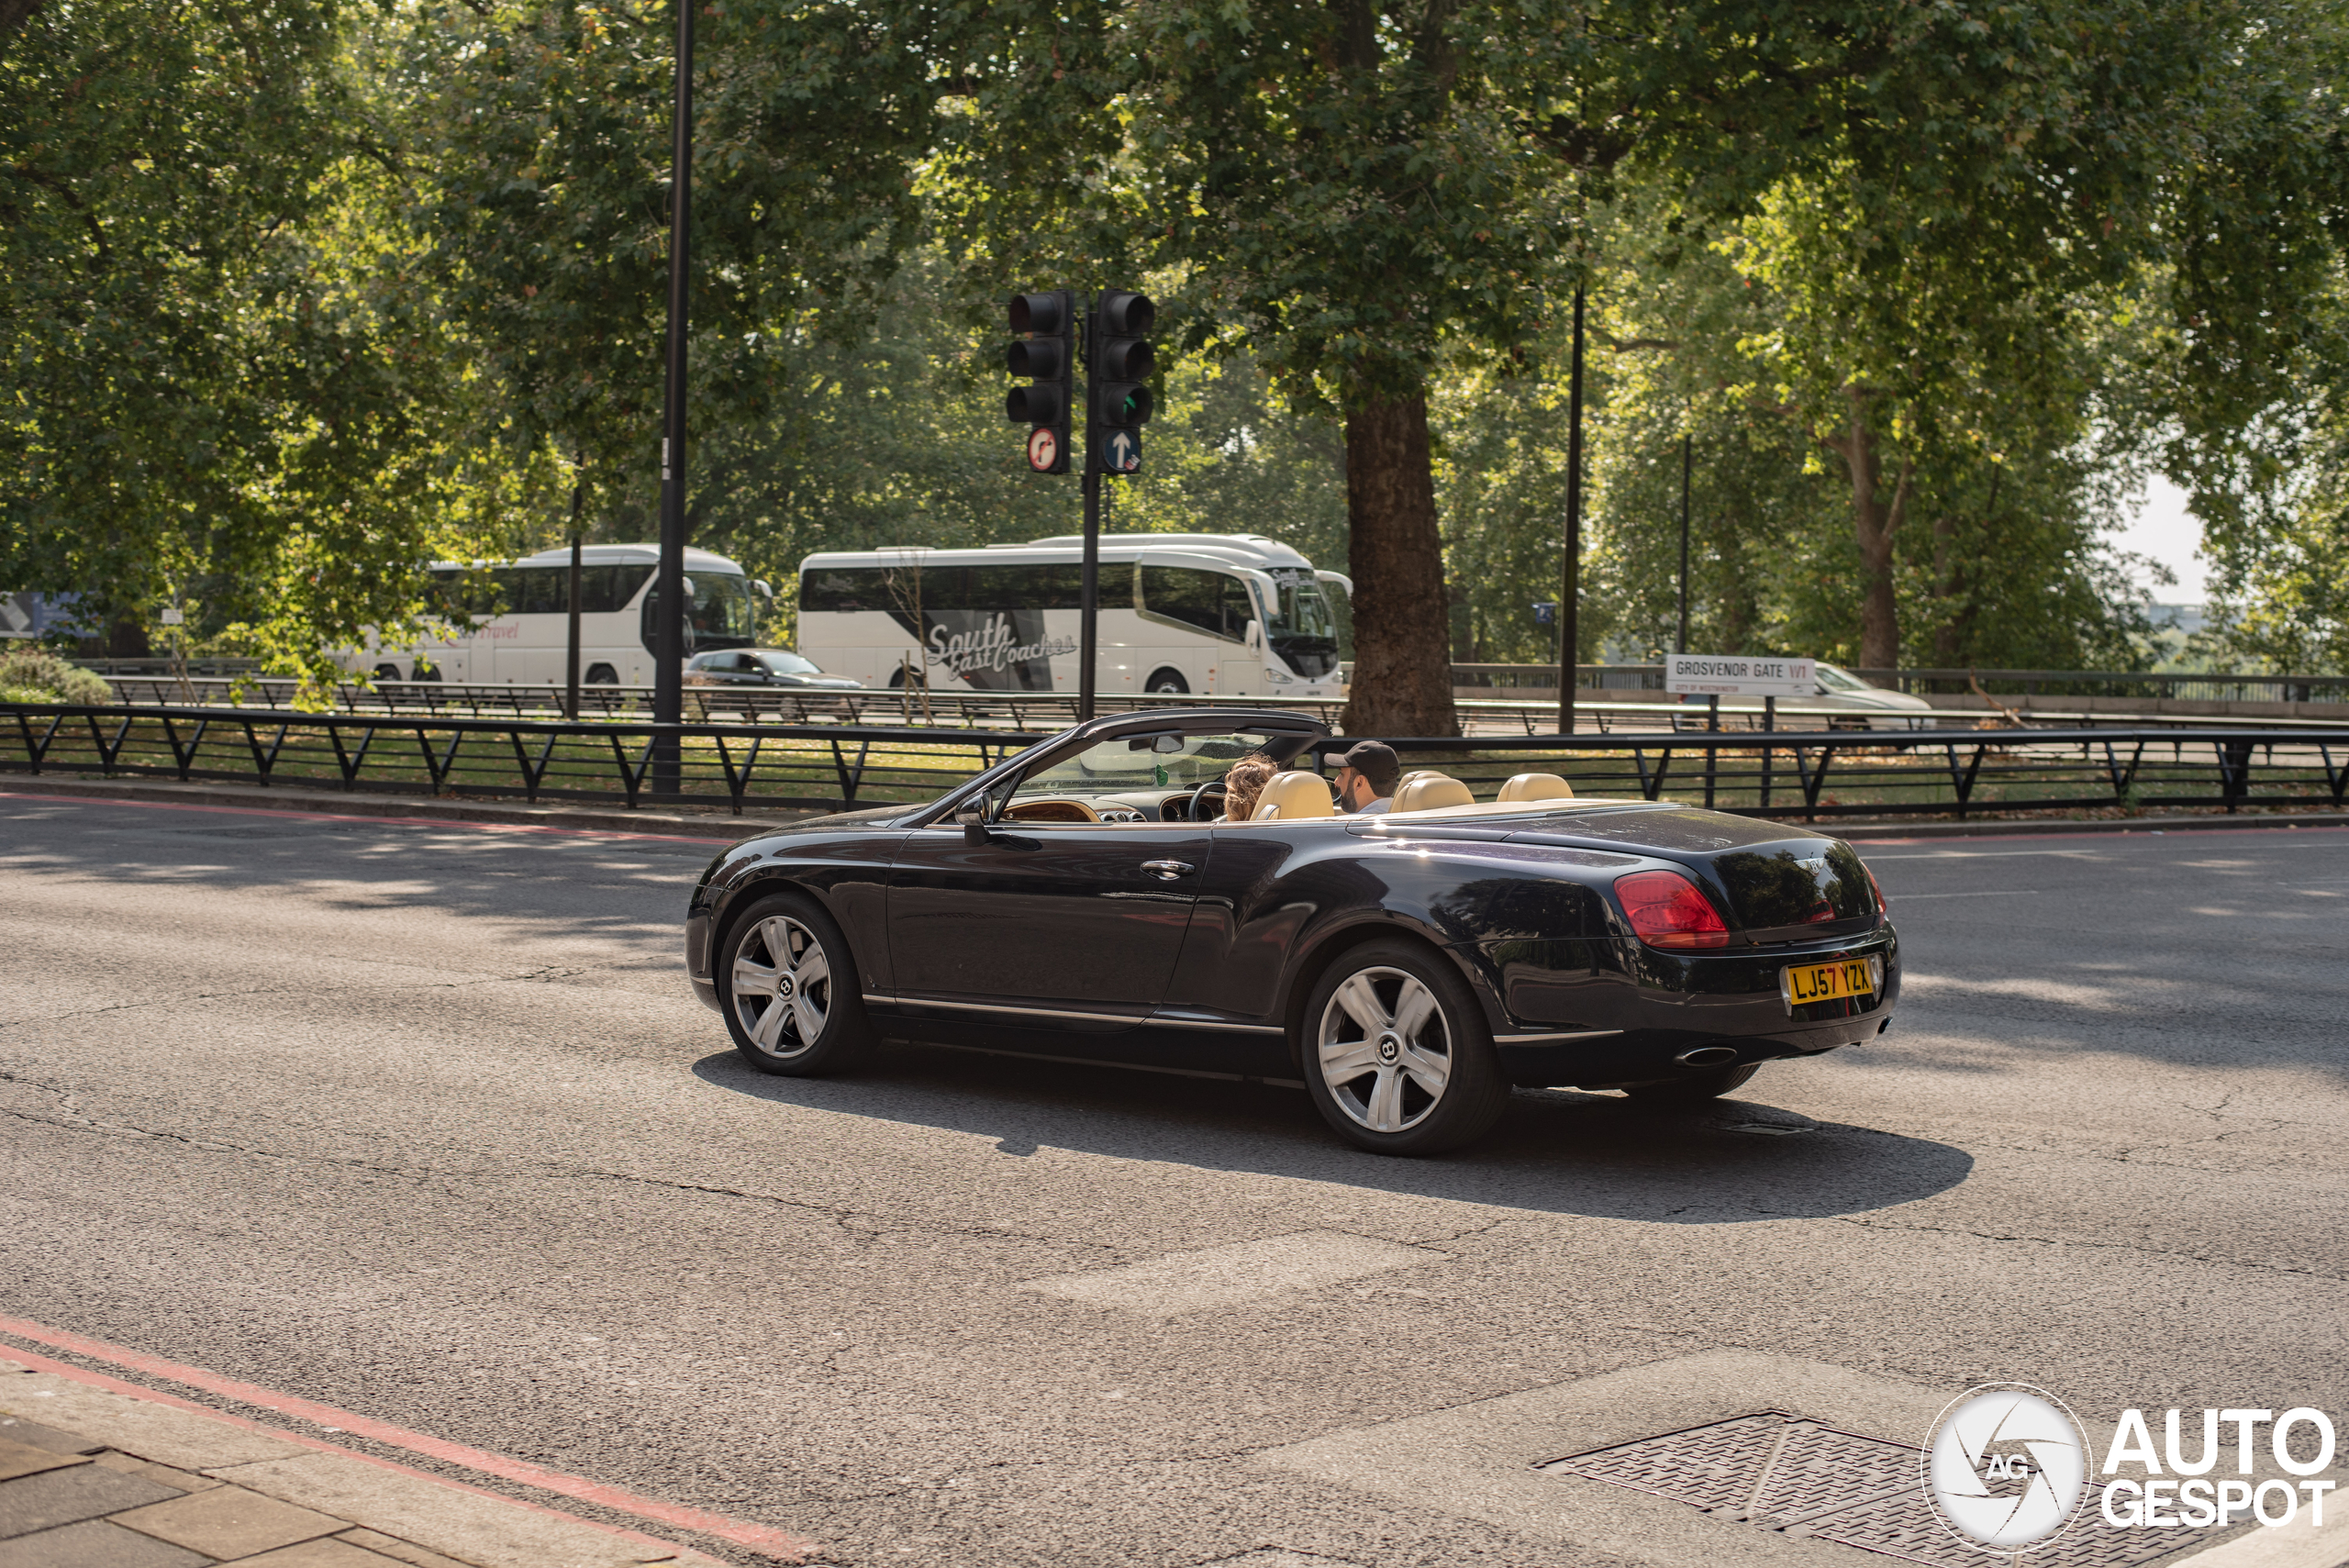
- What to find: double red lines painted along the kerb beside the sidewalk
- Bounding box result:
[0,1317,815,1563]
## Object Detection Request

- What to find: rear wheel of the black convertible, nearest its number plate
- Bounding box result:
[1304,939,1508,1155]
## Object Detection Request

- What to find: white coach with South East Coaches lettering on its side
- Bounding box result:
[798,533,1353,697]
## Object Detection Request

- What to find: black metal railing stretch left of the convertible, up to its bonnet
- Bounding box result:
[0,705,1041,815]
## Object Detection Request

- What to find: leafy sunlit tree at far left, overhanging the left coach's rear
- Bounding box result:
[0,0,538,672]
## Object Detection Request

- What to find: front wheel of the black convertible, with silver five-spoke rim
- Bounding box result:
[717,892,872,1077]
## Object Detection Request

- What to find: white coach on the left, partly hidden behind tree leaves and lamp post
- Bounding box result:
[340,545,773,685]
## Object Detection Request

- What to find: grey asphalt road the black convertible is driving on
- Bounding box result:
[0,795,2349,1568]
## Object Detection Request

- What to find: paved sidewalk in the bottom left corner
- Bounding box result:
[0,1359,718,1568]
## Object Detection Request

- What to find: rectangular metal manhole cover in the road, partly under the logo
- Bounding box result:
[1534,1411,2185,1568]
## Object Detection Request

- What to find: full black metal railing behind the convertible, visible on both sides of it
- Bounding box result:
[14,705,2349,819]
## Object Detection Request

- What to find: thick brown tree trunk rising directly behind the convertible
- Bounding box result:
[1343,392,1459,737]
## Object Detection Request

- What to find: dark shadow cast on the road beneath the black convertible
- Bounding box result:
[693,1044,1973,1225]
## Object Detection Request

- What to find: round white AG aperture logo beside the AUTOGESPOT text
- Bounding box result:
[1924,1383,2088,1550]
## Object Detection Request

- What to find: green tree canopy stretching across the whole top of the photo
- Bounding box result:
[0,0,2349,708]
